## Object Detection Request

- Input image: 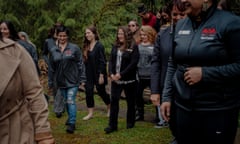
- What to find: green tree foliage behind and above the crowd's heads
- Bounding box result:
[0,0,163,58]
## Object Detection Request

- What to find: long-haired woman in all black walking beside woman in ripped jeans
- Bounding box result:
[83,26,110,120]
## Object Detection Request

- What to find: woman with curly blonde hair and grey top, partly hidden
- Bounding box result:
[136,25,157,121]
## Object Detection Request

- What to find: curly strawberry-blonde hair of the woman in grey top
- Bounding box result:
[140,25,157,44]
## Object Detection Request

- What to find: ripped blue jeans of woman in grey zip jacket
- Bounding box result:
[60,87,78,124]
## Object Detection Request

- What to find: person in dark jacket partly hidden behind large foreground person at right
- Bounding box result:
[150,0,186,144]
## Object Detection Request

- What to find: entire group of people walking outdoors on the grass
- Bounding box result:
[0,0,240,144]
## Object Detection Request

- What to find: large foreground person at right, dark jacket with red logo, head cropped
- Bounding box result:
[158,0,240,144]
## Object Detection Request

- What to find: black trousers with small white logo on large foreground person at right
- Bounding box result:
[176,107,239,144]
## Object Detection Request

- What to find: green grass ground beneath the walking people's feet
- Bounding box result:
[49,93,171,144]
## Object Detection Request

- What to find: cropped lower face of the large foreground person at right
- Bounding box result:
[181,0,209,16]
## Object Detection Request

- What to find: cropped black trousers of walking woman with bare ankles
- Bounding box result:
[85,82,110,108]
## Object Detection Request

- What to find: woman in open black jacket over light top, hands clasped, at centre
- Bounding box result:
[104,26,139,133]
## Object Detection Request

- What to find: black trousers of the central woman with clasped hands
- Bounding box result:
[109,82,137,128]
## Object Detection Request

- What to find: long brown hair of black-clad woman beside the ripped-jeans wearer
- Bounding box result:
[83,25,99,61]
